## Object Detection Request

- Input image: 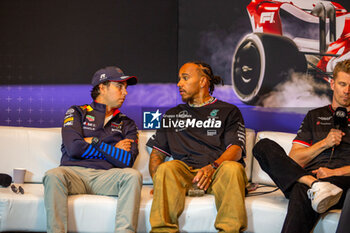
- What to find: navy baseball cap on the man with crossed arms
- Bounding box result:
[91,66,137,87]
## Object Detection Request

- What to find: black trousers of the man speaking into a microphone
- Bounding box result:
[253,139,350,233]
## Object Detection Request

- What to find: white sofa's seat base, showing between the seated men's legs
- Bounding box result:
[0,184,340,233]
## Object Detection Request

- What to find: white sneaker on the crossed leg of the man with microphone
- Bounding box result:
[307,181,343,214]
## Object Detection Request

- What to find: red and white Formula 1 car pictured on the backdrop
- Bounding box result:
[231,0,350,105]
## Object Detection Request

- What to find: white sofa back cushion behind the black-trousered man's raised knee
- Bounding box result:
[252,131,296,185]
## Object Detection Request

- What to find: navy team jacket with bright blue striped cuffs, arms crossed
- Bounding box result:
[61,102,138,169]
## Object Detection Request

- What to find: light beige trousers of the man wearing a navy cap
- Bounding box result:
[43,166,142,233]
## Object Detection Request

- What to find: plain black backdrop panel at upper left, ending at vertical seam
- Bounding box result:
[0,0,178,85]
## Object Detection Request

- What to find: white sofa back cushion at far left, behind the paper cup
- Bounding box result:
[0,126,62,182]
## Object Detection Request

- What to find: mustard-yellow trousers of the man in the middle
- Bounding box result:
[150,160,247,233]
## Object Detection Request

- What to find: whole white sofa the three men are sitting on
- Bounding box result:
[0,126,340,233]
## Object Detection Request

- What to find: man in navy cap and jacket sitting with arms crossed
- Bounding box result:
[43,66,142,232]
